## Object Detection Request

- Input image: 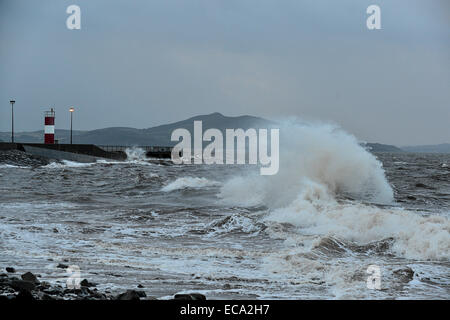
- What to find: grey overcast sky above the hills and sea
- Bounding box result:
[0,0,450,145]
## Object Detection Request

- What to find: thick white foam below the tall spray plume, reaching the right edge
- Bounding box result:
[265,183,450,260]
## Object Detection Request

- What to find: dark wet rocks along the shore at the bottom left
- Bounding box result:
[0,267,206,301]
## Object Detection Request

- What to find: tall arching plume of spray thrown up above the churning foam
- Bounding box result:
[220,123,393,208]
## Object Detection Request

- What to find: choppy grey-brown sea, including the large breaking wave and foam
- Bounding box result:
[0,139,450,299]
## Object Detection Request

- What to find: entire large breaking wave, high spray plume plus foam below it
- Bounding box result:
[220,123,450,259]
